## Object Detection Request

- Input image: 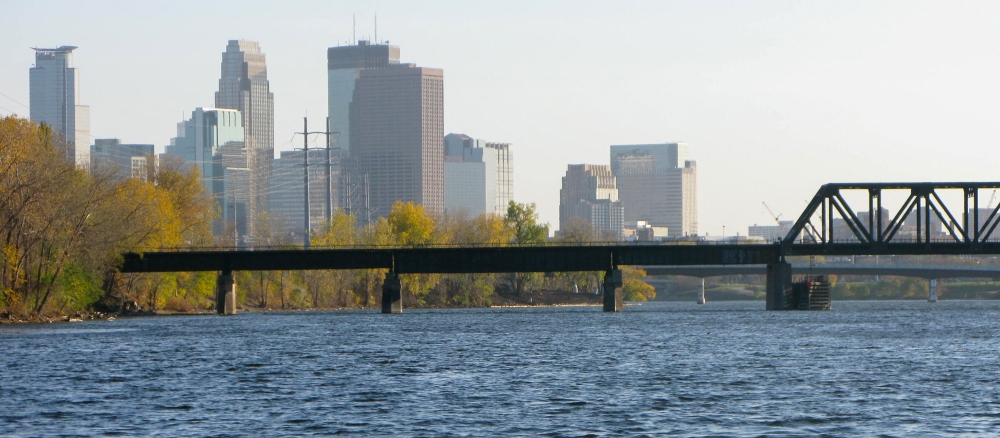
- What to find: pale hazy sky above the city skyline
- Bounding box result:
[0,0,1000,235]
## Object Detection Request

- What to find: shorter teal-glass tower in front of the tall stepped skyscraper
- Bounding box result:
[166,108,252,240]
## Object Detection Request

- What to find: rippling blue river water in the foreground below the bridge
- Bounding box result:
[0,301,1000,436]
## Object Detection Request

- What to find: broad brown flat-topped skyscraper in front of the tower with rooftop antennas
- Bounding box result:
[348,64,444,218]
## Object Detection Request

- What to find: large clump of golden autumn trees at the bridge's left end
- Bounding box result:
[0,116,213,314]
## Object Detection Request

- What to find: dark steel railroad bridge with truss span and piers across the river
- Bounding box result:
[120,182,1000,314]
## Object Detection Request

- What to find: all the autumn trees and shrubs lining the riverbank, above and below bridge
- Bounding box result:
[0,116,997,322]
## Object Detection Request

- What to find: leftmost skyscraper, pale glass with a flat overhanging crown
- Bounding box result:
[28,46,90,166]
